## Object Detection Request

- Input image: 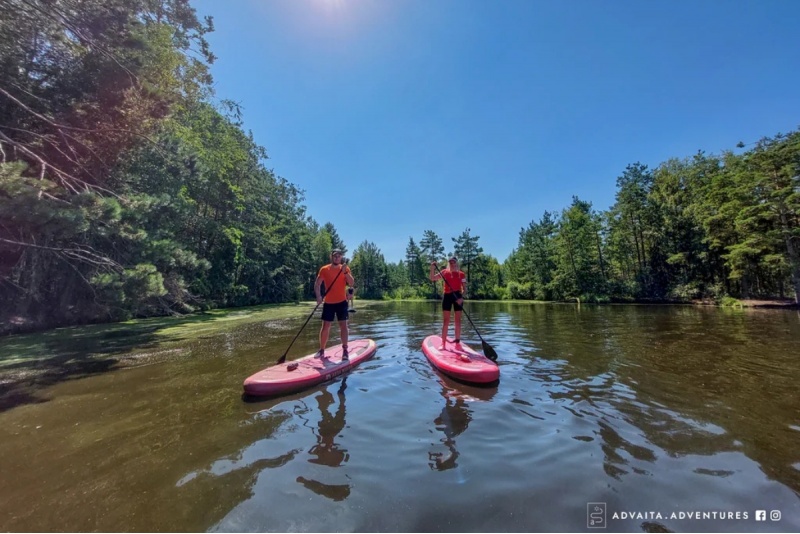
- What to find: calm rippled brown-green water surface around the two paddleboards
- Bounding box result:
[0,302,800,532]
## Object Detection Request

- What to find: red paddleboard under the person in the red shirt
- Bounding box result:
[422,336,500,384]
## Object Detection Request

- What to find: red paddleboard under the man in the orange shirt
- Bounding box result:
[244,339,376,397]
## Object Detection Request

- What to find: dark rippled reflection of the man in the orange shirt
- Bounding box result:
[297,377,350,501]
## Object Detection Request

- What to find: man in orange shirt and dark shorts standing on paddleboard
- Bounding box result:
[314,248,355,360]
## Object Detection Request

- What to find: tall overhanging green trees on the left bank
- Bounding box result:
[0,0,322,336]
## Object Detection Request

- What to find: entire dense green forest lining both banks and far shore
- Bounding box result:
[0,0,800,333]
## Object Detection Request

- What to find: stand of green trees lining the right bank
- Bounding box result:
[503,132,800,301]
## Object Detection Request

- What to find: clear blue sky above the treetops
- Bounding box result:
[192,0,800,262]
